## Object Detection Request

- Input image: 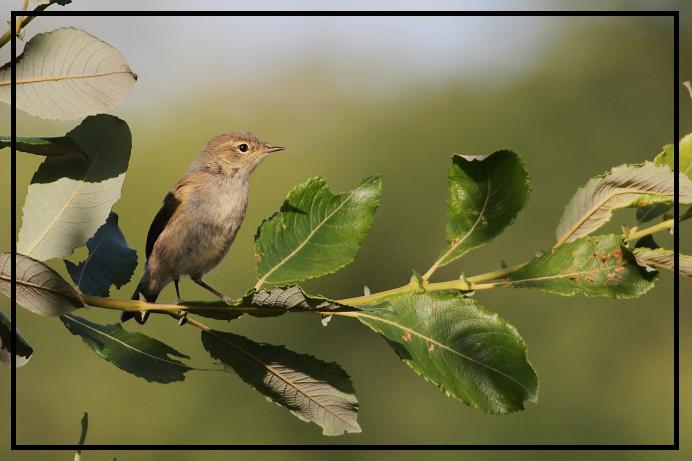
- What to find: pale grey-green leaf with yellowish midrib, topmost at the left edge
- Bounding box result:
[0,27,137,120]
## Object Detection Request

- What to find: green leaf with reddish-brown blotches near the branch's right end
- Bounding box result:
[501,234,656,298]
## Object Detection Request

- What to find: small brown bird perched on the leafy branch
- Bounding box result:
[121,131,284,323]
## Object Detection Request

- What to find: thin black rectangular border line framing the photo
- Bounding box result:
[10,10,680,451]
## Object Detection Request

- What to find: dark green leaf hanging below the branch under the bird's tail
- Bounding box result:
[60,315,192,383]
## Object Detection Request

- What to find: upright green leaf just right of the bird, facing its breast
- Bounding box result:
[255,176,382,287]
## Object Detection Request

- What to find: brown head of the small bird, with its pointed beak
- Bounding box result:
[199,131,284,175]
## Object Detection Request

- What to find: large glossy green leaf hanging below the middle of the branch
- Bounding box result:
[357,292,538,414]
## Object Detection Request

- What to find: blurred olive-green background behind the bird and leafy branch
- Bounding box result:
[0,1,692,460]
